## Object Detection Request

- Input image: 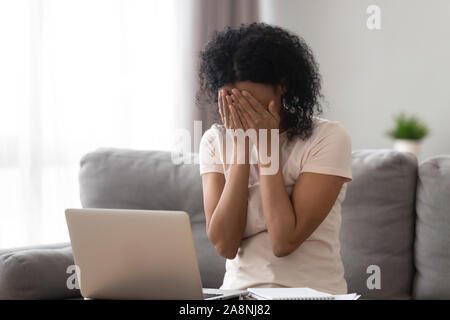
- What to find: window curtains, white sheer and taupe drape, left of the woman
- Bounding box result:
[0,0,257,249]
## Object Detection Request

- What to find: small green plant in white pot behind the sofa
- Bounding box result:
[387,113,429,157]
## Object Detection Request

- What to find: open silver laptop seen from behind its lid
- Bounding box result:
[65,209,247,300]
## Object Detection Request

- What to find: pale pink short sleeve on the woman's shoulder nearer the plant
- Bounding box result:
[300,122,352,180]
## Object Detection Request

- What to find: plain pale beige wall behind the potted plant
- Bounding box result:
[260,0,450,160]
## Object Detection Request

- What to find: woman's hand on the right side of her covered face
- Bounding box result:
[231,89,280,140]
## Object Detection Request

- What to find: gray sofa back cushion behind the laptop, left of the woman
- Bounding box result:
[79,148,225,288]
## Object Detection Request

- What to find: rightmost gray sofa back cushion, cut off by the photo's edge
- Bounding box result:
[413,156,450,299]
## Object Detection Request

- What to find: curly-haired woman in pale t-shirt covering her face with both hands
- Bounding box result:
[197,23,352,294]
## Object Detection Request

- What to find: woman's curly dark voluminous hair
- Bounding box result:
[196,22,322,140]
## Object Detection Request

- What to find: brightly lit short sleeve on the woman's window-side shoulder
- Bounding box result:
[199,126,224,175]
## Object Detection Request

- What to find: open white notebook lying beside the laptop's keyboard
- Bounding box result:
[247,288,335,300]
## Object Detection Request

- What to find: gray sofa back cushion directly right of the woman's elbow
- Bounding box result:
[340,150,417,299]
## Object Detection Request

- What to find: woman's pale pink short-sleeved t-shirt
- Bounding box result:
[200,117,352,294]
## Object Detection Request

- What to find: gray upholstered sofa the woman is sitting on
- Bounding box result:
[0,148,450,299]
